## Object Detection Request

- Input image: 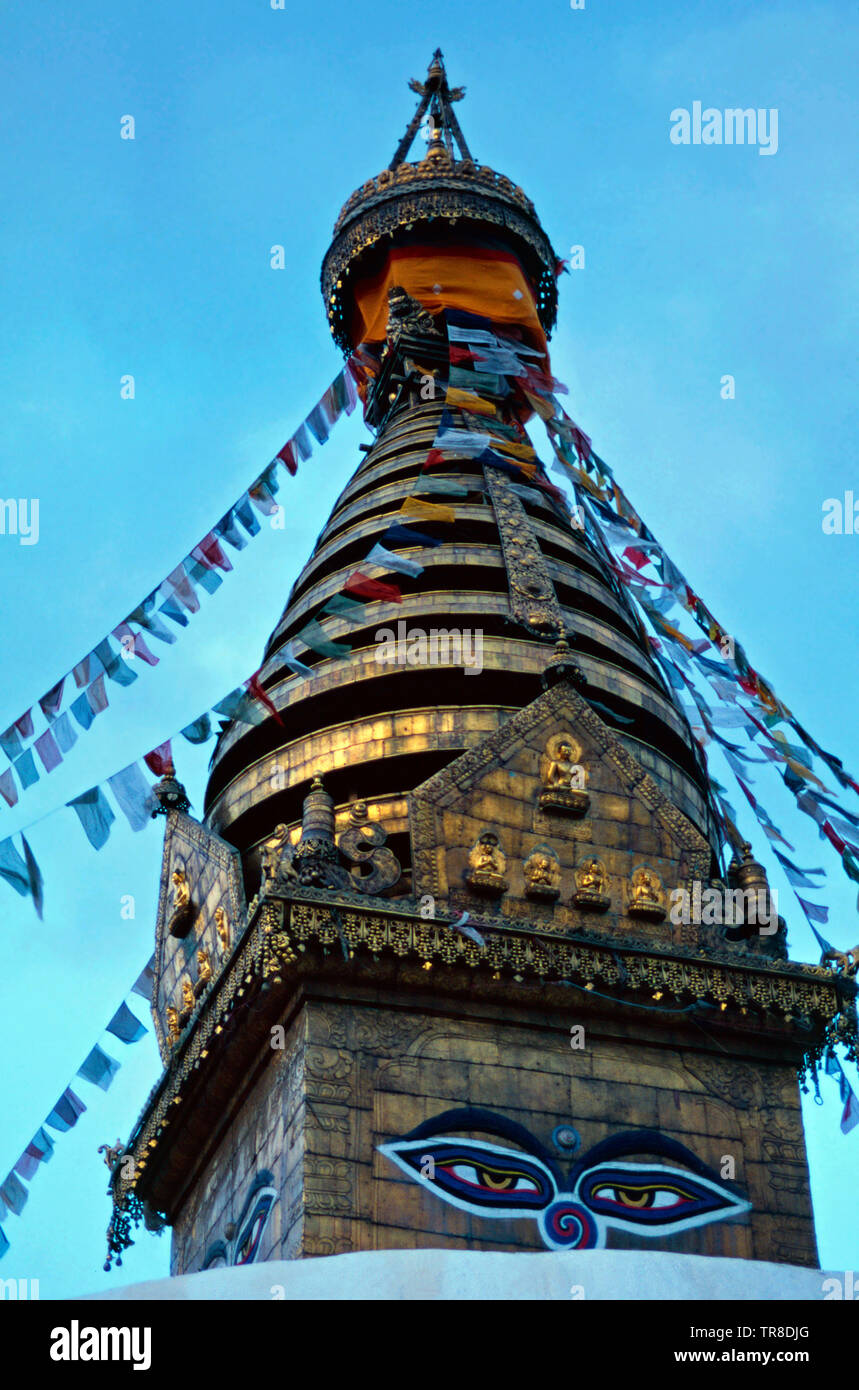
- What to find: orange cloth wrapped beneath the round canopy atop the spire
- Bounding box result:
[352,243,546,350]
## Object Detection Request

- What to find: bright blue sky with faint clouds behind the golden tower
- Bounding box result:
[0,0,859,1297]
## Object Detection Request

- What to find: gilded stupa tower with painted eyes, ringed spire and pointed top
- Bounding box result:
[105,54,840,1273]
